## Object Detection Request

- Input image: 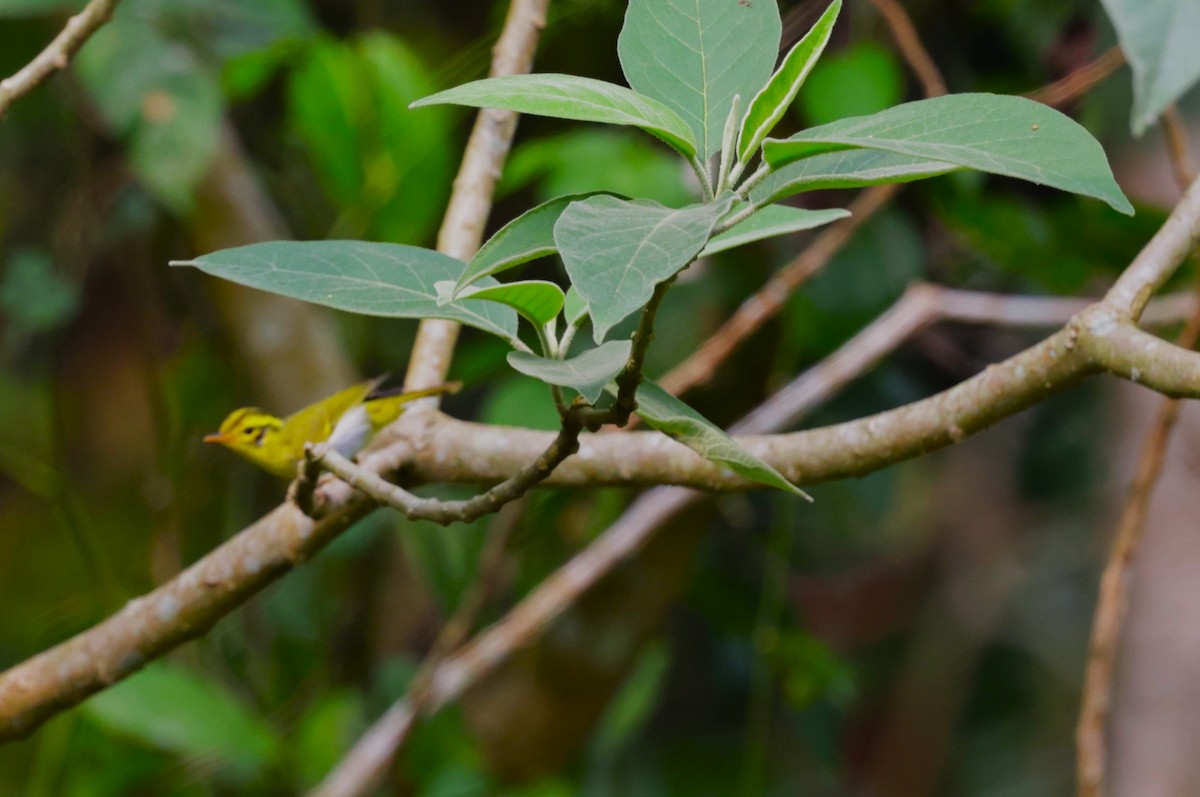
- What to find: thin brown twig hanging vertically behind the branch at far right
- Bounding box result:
[1075,107,1200,797]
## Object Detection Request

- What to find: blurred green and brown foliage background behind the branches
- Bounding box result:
[0,0,1200,797]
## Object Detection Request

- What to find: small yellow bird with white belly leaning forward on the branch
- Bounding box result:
[204,377,462,479]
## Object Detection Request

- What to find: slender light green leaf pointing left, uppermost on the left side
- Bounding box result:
[410,74,696,157]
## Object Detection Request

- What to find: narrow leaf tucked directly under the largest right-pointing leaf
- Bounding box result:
[750,150,962,205]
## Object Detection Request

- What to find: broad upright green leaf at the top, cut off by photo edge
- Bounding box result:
[617,0,781,158]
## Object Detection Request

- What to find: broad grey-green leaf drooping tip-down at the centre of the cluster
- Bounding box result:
[554,196,732,343]
